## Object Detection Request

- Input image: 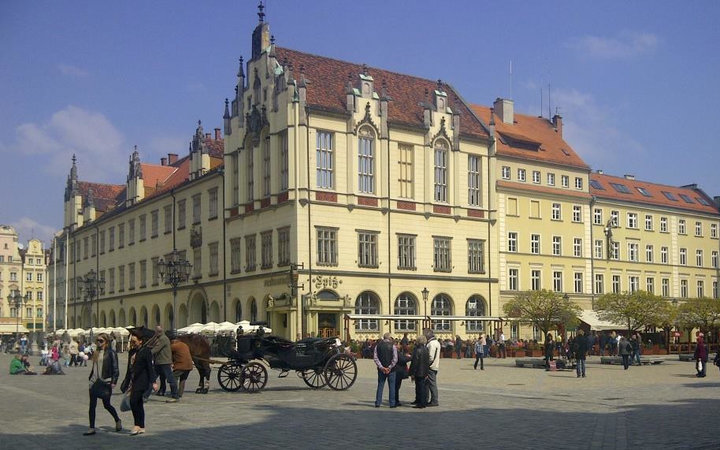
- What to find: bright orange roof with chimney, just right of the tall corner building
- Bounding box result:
[472,105,590,170]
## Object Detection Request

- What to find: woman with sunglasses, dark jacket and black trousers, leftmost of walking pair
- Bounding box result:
[83,333,122,436]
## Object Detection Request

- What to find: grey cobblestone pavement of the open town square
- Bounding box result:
[0,354,720,449]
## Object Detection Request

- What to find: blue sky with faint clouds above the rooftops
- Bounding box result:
[0,0,720,246]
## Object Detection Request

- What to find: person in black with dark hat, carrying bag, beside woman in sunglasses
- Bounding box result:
[123,327,155,436]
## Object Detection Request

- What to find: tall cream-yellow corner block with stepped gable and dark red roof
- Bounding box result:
[225,17,498,339]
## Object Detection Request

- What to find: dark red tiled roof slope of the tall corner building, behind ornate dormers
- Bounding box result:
[275,47,489,138]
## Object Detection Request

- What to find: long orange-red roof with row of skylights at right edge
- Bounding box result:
[590,173,719,214]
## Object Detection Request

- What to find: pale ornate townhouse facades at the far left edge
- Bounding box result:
[0,225,47,333]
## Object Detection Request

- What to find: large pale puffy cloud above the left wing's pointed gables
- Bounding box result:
[0,106,130,182]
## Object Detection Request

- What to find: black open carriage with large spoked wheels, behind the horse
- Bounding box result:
[217,329,357,392]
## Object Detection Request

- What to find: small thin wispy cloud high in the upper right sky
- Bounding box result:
[567,31,660,59]
